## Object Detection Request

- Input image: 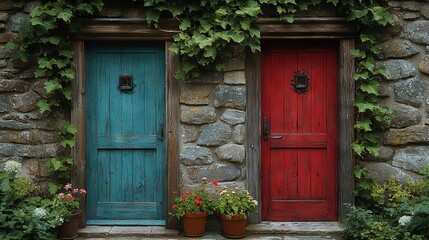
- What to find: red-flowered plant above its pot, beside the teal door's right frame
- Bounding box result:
[173,178,218,218]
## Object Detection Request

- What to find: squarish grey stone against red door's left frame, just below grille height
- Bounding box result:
[214,85,246,110]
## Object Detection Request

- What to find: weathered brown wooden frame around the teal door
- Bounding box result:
[71,19,180,228]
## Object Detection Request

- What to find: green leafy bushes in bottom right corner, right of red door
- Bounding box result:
[345,166,429,240]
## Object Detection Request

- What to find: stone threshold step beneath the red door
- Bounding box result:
[246,221,344,237]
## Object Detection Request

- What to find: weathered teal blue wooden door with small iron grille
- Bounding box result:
[86,42,166,225]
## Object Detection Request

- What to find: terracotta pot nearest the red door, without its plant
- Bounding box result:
[220,213,247,238]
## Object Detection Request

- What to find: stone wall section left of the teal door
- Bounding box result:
[0,0,63,189]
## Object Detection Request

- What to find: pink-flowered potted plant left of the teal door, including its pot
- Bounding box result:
[53,183,86,239]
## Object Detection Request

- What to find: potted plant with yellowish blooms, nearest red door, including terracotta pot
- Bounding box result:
[217,188,258,238]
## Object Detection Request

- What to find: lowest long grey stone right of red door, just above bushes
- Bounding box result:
[361,162,421,184]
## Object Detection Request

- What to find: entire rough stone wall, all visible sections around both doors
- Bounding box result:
[0,0,429,187]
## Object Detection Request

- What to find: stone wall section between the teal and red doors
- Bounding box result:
[180,47,246,187]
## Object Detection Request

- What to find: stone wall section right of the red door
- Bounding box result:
[363,1,429,184]
